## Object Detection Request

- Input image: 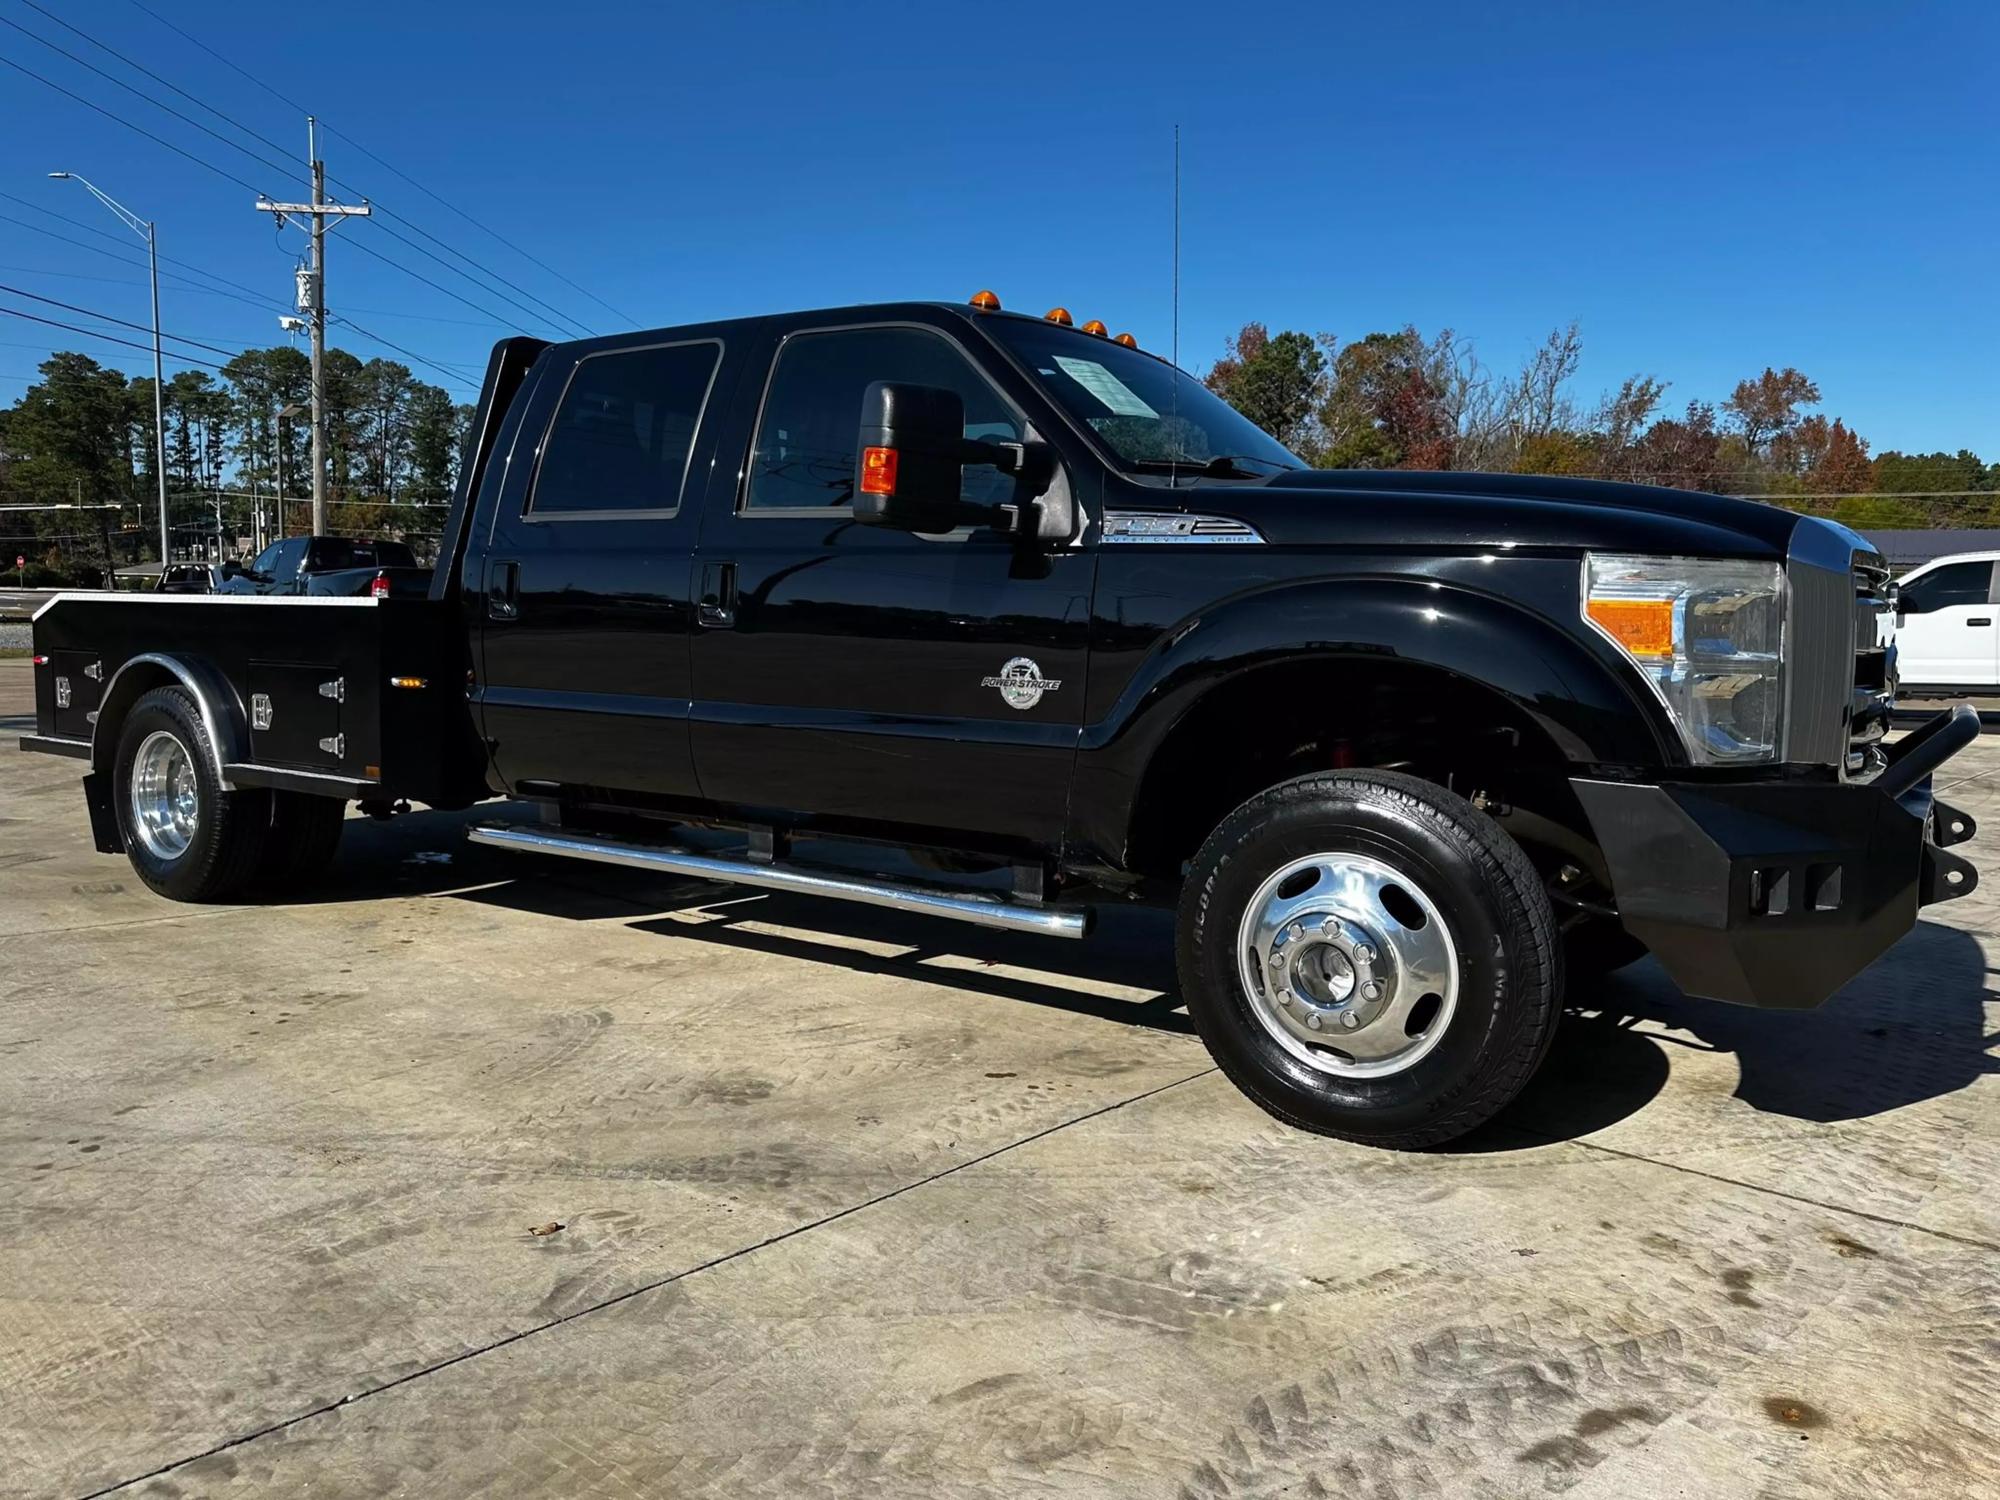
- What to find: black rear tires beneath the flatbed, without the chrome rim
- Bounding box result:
[112,688,270,902]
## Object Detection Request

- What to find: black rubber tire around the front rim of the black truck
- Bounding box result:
[1176,772,1562,1150]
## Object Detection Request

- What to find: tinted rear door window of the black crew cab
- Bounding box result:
[528,342,722,516]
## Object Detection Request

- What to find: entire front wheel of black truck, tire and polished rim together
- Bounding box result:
[1178,772,1562,1148]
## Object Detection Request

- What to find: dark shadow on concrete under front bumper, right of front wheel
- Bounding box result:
[1460,922,2000,1150]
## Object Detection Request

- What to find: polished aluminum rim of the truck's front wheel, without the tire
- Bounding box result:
[1236,854,1458,1078]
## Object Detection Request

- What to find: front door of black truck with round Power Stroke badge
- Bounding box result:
[692,320,1094,848]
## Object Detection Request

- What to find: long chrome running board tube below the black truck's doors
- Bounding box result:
[466,824,1090,938]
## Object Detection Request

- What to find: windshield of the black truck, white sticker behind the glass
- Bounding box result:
[982,318,1306,476]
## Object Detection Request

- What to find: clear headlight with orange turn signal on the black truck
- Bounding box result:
[1584,554,1784,766]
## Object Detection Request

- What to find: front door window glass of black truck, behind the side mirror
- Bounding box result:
[744,328,1022,512]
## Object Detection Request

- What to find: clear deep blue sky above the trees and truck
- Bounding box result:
[0,0,2000,460]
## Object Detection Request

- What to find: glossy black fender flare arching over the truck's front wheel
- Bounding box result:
[1072,570,1686,858]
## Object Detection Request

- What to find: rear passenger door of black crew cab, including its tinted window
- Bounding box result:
[464,336,728,798]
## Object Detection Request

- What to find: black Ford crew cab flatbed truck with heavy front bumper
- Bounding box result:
[22,294,1976,1146]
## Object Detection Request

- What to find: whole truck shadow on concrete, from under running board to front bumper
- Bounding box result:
[312,806,2000,1150]
